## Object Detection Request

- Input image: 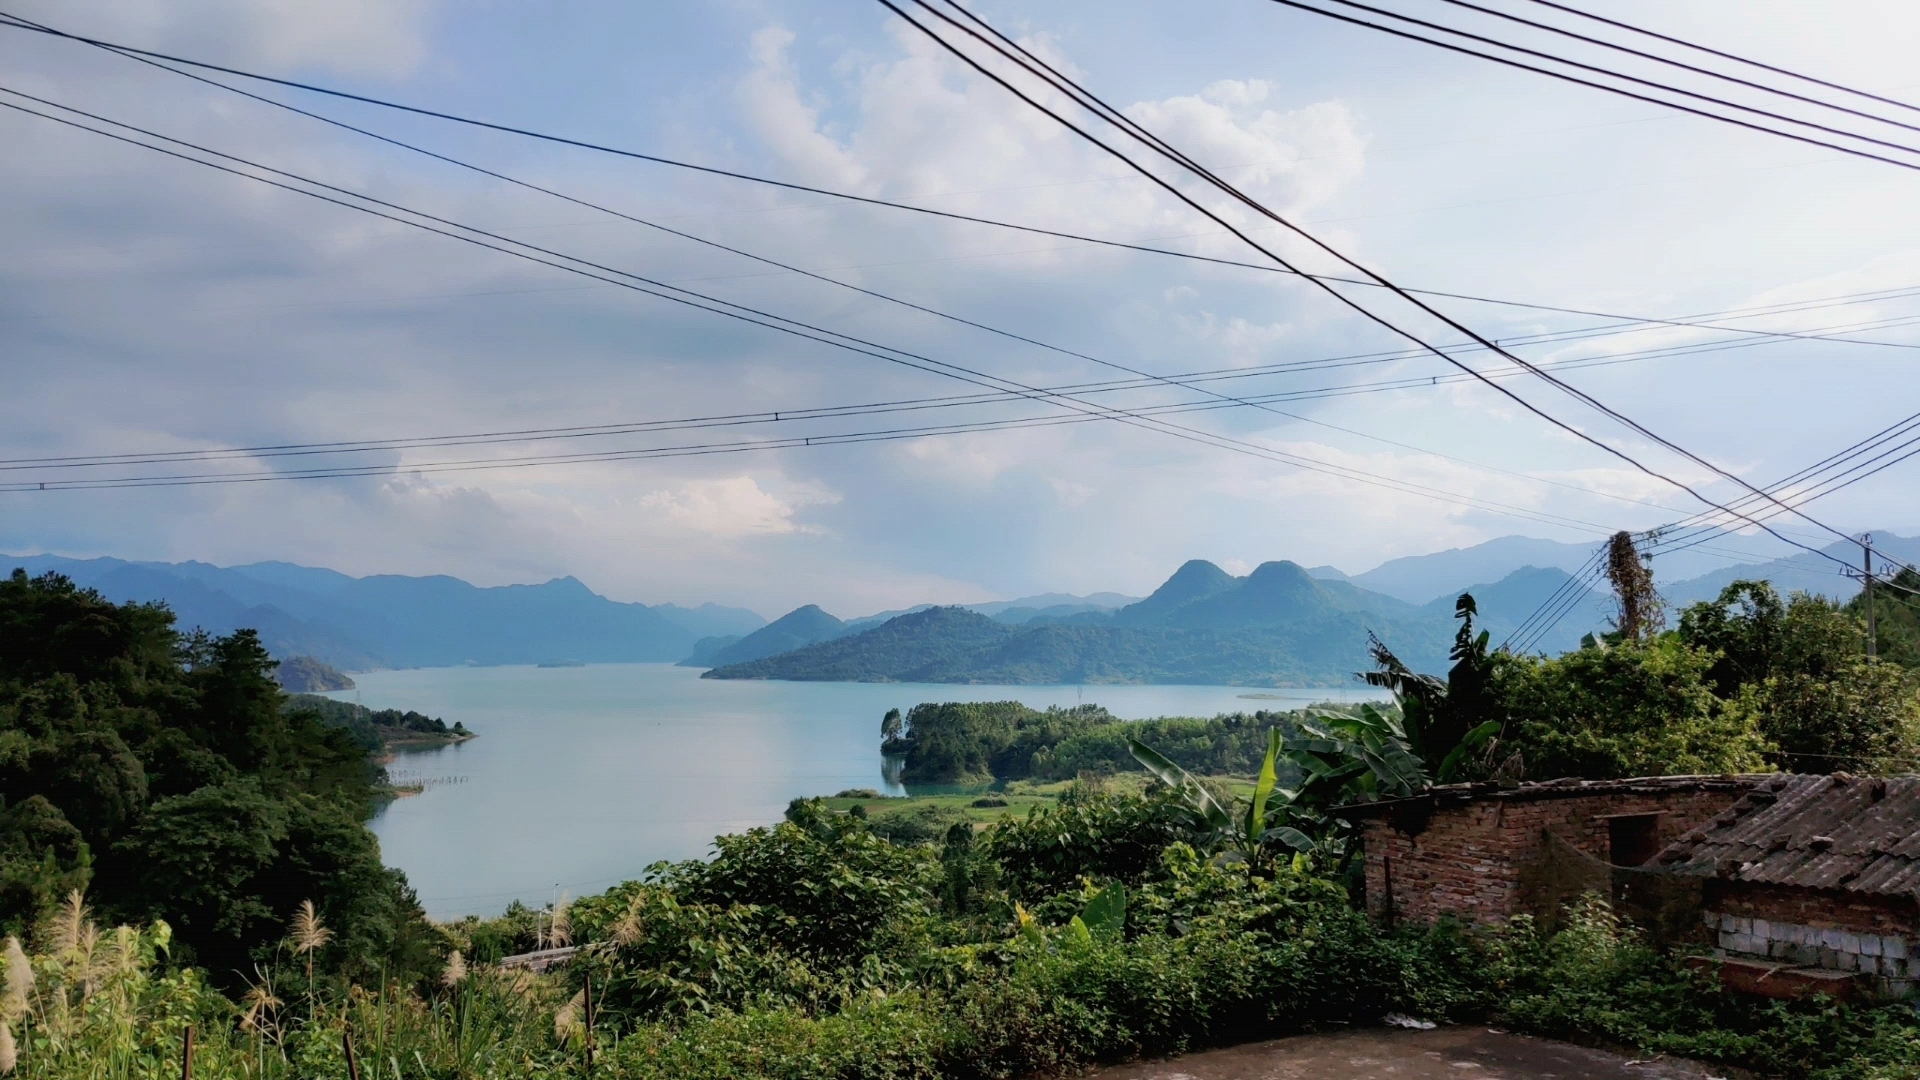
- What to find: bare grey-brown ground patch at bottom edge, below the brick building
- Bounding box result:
[1089,1028,1726,1080]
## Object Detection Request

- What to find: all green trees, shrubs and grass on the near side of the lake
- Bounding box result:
[0,553,1920,1080]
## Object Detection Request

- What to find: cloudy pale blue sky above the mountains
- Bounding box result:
[0,0,1920,615]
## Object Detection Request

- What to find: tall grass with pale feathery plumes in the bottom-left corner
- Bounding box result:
[0,894,580,1080]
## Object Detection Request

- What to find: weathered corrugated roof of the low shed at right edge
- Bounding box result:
[1655,773,1920,896]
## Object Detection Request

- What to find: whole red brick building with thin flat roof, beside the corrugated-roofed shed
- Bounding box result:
[1334,776,1768,924]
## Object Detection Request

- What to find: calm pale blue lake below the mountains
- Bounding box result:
[330,663,1379,919]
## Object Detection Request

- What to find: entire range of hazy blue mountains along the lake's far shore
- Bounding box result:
[11,534,1920,686]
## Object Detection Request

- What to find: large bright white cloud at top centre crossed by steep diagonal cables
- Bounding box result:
[739,25,1365,265]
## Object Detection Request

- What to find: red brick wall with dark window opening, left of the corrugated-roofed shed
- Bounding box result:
[1363,790,1740,924]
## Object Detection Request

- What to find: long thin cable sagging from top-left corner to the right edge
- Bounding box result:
[0,12,1920,348]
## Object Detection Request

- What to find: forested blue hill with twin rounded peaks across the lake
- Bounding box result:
[707,559,1603,686]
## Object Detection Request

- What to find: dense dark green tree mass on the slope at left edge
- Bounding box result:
[0,571,430,982]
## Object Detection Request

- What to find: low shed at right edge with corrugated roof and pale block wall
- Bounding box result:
[1651,773,1920,997]
